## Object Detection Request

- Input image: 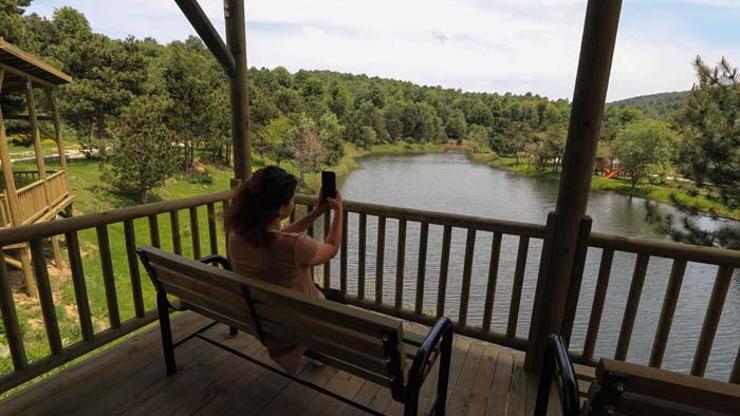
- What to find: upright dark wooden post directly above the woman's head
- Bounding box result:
[224,0,252,186]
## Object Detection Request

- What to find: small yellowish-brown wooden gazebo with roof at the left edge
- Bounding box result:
[0,37,72,295]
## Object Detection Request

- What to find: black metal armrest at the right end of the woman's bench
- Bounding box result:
[406,317,453,414]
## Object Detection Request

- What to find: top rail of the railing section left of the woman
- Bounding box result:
[0,191,230,246]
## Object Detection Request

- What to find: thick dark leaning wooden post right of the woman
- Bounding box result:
[525,0,622,372]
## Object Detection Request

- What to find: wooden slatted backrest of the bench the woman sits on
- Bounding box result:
[139,247,404,389]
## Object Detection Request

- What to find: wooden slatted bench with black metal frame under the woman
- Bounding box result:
[137,247,453,415]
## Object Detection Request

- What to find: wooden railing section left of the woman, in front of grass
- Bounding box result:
[0,192,228,392]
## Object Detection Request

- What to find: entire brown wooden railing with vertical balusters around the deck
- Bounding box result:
[0,192,740,391]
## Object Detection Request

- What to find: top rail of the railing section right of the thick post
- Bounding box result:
[589,232,740,268]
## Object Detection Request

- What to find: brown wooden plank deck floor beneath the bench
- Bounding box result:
[0,312,537,416]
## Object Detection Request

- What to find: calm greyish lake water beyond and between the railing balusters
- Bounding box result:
[317,153,740,380]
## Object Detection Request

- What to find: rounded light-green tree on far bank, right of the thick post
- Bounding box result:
[613,119,677,188]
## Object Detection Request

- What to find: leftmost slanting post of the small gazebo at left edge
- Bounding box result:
[0,69,38,297]
